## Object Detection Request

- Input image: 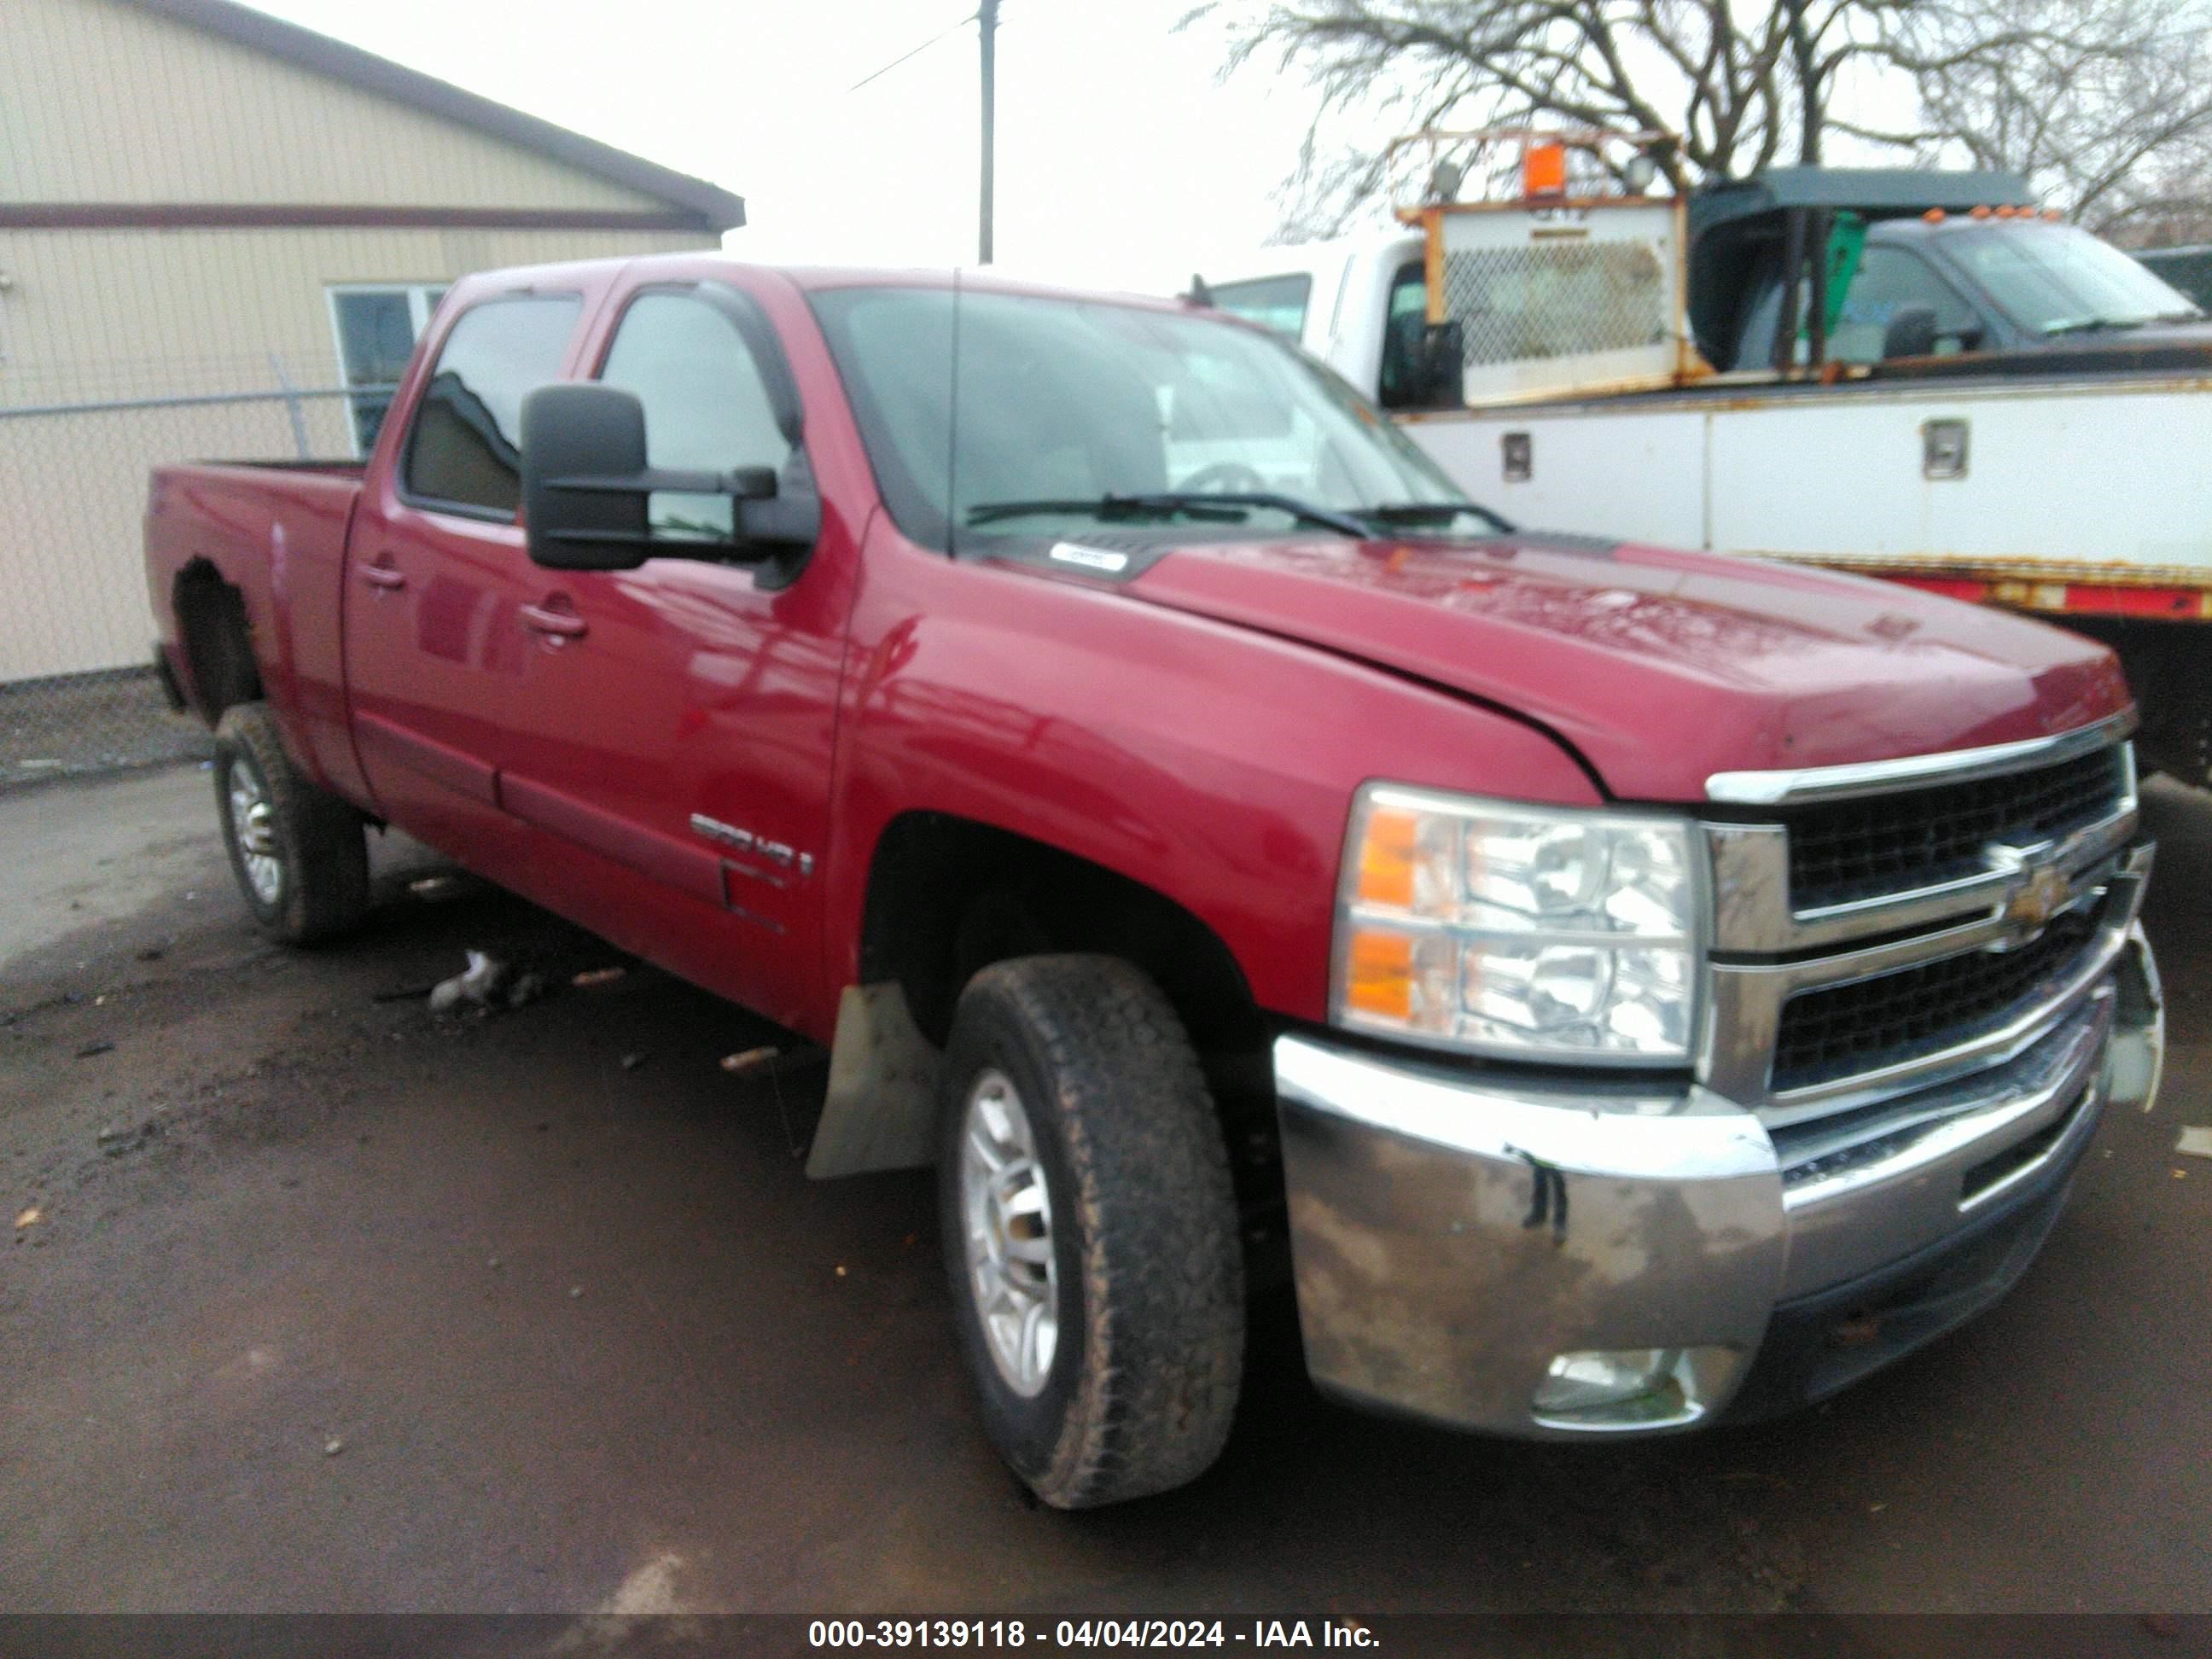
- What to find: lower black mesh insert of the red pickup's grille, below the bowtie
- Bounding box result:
[1772,911,2095,1092]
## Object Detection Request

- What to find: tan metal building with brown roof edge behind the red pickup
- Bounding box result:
[0,0,746,686]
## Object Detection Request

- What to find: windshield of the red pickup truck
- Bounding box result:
[812,288,1499,550]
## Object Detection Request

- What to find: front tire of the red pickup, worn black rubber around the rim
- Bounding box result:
[938,956,1245,1509]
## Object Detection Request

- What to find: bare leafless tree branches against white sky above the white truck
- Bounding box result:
[1184,0,2212,243]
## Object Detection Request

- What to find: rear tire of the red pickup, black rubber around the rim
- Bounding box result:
[214,703,370,945]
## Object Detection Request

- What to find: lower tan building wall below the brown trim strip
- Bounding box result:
[0,230,714,684]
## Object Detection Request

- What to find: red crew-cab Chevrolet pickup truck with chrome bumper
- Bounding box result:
[146,254,2161,1506]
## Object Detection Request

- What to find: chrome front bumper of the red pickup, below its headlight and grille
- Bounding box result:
[1274,911,2163,1438]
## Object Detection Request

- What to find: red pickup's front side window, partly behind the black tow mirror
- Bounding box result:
[599,290,792,539]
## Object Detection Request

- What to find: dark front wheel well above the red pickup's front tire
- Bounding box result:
[860,812,1266,1055]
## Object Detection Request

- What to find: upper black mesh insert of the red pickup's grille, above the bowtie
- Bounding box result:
[1785,746,2128,911]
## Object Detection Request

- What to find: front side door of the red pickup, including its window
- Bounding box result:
[484,268,854,1020]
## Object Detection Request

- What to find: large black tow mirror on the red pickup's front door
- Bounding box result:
[522,381,821,571]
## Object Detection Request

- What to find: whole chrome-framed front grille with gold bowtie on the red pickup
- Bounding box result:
[1697,717,2152,1131]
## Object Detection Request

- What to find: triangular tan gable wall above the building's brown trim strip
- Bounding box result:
[0,0,668,210]
